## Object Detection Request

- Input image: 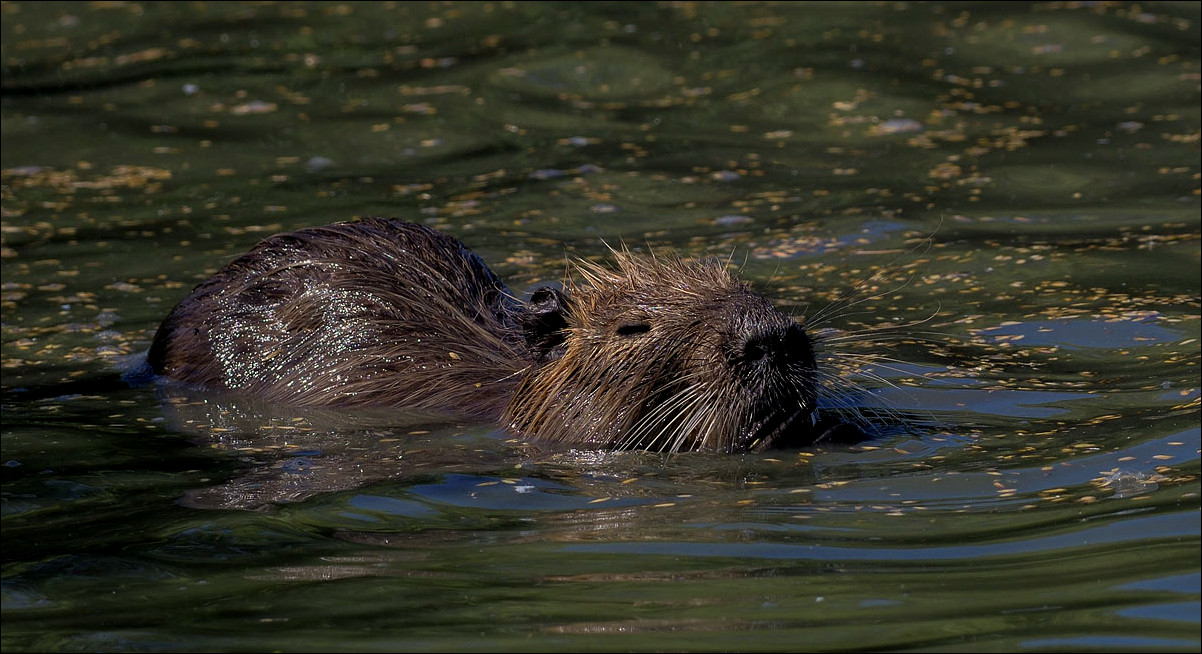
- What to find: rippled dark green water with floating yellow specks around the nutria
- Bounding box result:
[0,2,1202,652]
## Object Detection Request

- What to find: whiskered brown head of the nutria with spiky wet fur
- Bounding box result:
[505,251,816,452]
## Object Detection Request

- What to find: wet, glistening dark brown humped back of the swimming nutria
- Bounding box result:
[147,218,526,418]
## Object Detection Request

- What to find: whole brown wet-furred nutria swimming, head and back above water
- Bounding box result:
[148,218,841,452]
